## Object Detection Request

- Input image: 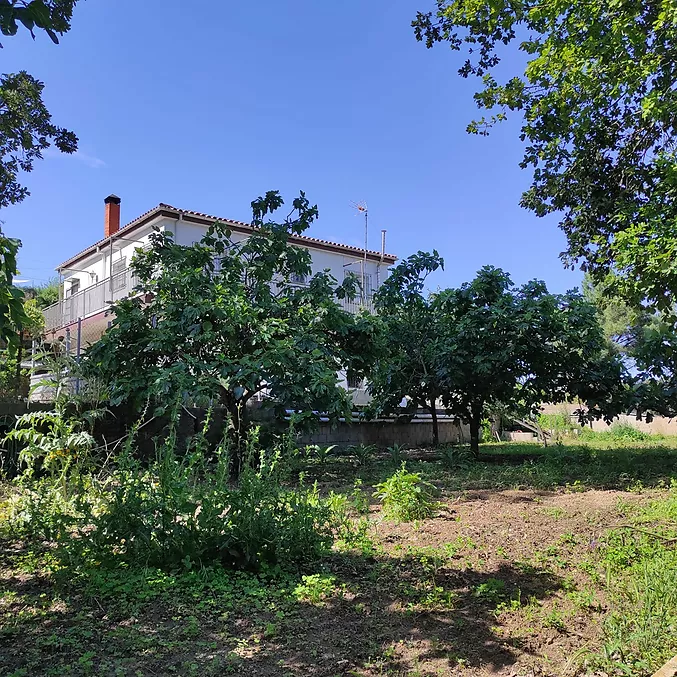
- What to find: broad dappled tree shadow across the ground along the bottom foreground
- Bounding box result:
[0,555,563,677]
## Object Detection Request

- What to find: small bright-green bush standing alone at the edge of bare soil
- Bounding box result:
[374,463,437,522]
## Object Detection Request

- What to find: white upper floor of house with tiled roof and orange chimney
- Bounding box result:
[45,195,396,336]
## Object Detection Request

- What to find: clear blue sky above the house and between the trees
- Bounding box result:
[0,0,581,292]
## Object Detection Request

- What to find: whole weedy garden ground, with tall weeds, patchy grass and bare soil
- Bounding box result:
[0,431,677,677]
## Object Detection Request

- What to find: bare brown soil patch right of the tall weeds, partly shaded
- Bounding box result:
[262,491,646,677]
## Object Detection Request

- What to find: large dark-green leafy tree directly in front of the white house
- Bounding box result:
[84,192,375,464]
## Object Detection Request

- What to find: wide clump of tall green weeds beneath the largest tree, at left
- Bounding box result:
[4,422,337,569]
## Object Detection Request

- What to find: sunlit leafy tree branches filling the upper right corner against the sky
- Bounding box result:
[413,0,677,310]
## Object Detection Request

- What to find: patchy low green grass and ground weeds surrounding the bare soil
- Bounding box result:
[0,438,677,677]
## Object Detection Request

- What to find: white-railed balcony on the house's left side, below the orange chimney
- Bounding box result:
[43,268,138,332]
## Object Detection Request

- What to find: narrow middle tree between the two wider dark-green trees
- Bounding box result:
[369,251,444,444]
